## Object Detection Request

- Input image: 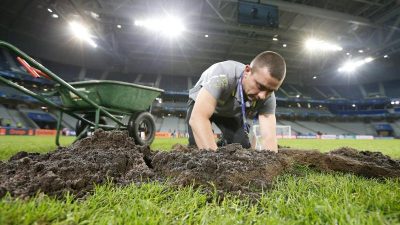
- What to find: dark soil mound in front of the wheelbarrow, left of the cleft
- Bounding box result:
[0,131,154,197]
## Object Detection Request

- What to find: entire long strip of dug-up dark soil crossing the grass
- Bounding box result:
[0,130,400,197]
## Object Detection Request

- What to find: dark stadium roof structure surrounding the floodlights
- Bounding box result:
[0,0,400,83]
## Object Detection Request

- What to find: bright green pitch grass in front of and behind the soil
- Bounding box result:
[0,137,400,224]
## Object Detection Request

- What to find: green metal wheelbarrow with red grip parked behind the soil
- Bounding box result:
[0,41,163,146]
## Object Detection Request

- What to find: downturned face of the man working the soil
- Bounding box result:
[242,65,283,101]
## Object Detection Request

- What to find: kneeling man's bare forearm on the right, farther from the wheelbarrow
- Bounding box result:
[258,114,278,152]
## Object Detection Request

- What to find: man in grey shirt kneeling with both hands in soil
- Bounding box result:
[186,51,286,151]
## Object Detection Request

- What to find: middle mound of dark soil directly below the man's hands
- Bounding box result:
[152,144,289,192]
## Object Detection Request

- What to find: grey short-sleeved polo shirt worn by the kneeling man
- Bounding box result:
[189,60,276,118]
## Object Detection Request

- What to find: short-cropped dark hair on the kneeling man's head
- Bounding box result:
[250,51,286,81]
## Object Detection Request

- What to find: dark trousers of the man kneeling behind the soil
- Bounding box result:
[186,100,251,148]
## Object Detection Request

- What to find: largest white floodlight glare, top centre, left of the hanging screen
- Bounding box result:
[135,17,185,37]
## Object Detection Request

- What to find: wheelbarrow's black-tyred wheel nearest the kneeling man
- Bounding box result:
[128,112,156,145]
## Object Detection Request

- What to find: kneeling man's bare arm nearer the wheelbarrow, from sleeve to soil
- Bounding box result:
[189,88,217,150]
